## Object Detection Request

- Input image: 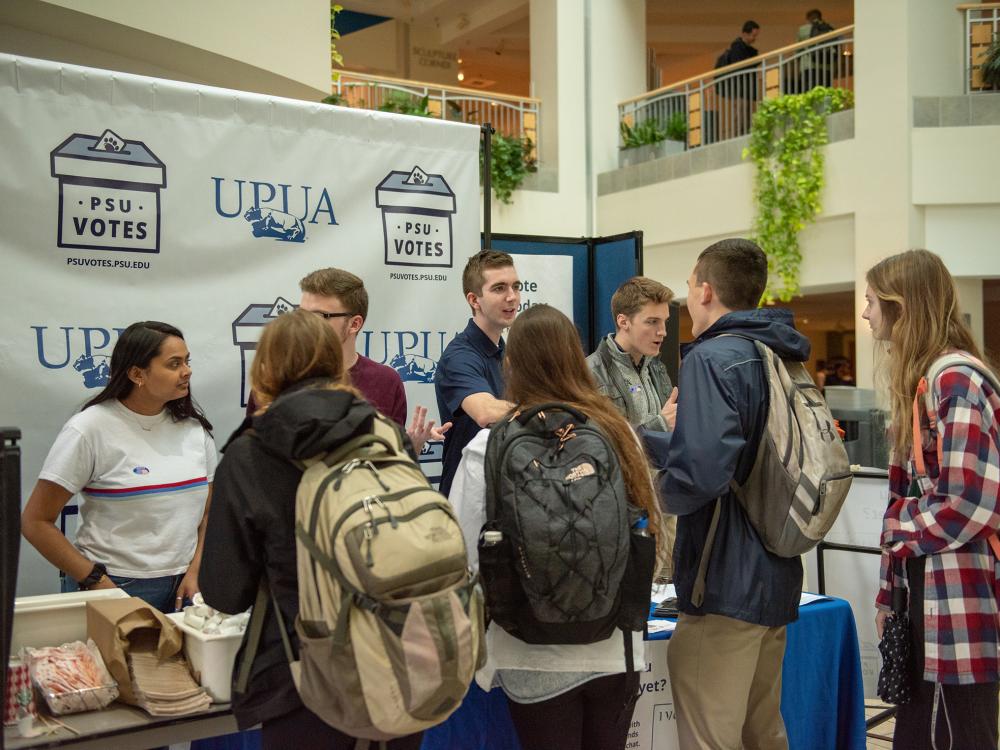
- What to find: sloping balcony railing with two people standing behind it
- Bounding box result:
[618,25,854,149]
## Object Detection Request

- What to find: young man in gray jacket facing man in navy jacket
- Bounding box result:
[587,276,677,578]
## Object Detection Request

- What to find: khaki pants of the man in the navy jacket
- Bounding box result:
[667,614,788,750]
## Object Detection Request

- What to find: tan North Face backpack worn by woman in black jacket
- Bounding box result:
[237,415,486,740]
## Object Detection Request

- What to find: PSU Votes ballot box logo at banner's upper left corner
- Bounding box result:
[49,130,167,253]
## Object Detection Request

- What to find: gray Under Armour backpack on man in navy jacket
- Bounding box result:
[691,334,853,606]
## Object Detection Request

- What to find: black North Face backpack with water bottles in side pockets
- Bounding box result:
[478,404,656,652]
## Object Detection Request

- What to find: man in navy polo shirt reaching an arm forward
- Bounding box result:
[434,250,521,495]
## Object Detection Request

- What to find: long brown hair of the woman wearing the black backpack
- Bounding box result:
[504,304,666,556]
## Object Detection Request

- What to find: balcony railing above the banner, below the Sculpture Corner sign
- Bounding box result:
[333,71,541,158]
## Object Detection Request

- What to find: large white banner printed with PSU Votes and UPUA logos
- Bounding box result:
[0,55,480,595]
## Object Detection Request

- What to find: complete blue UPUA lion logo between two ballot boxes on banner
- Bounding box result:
[212,177,337,242]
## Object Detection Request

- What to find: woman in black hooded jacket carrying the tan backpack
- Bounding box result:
[199,310,422,750]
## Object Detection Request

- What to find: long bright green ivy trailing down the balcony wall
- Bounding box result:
[743,86,854,301]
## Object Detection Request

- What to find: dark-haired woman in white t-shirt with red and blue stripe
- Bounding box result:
[21,321,216,612]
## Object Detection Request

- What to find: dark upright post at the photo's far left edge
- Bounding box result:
[0,427,21,750]
